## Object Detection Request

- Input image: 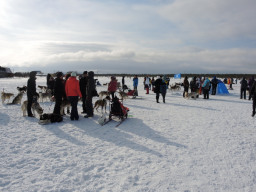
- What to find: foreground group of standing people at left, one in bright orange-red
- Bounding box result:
[27,71,97,121]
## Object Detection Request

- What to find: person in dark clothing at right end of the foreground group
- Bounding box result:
[84,71,96,118]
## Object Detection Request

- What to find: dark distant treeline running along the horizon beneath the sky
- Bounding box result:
[14,72,256,79]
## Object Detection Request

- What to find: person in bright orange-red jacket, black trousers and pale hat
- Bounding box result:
[65,72,82,121]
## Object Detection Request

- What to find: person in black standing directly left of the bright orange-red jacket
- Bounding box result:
[53,72,66,115]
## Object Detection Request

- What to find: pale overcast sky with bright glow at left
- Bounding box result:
[0,0,256,73]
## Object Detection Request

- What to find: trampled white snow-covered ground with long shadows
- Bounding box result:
[0,77,256,192]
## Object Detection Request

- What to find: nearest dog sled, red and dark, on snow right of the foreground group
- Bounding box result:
[99,97,129,127]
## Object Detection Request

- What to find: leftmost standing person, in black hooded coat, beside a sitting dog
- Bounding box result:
[27,71,39,117]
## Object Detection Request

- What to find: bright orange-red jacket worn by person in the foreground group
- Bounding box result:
[65,77,82,97]
